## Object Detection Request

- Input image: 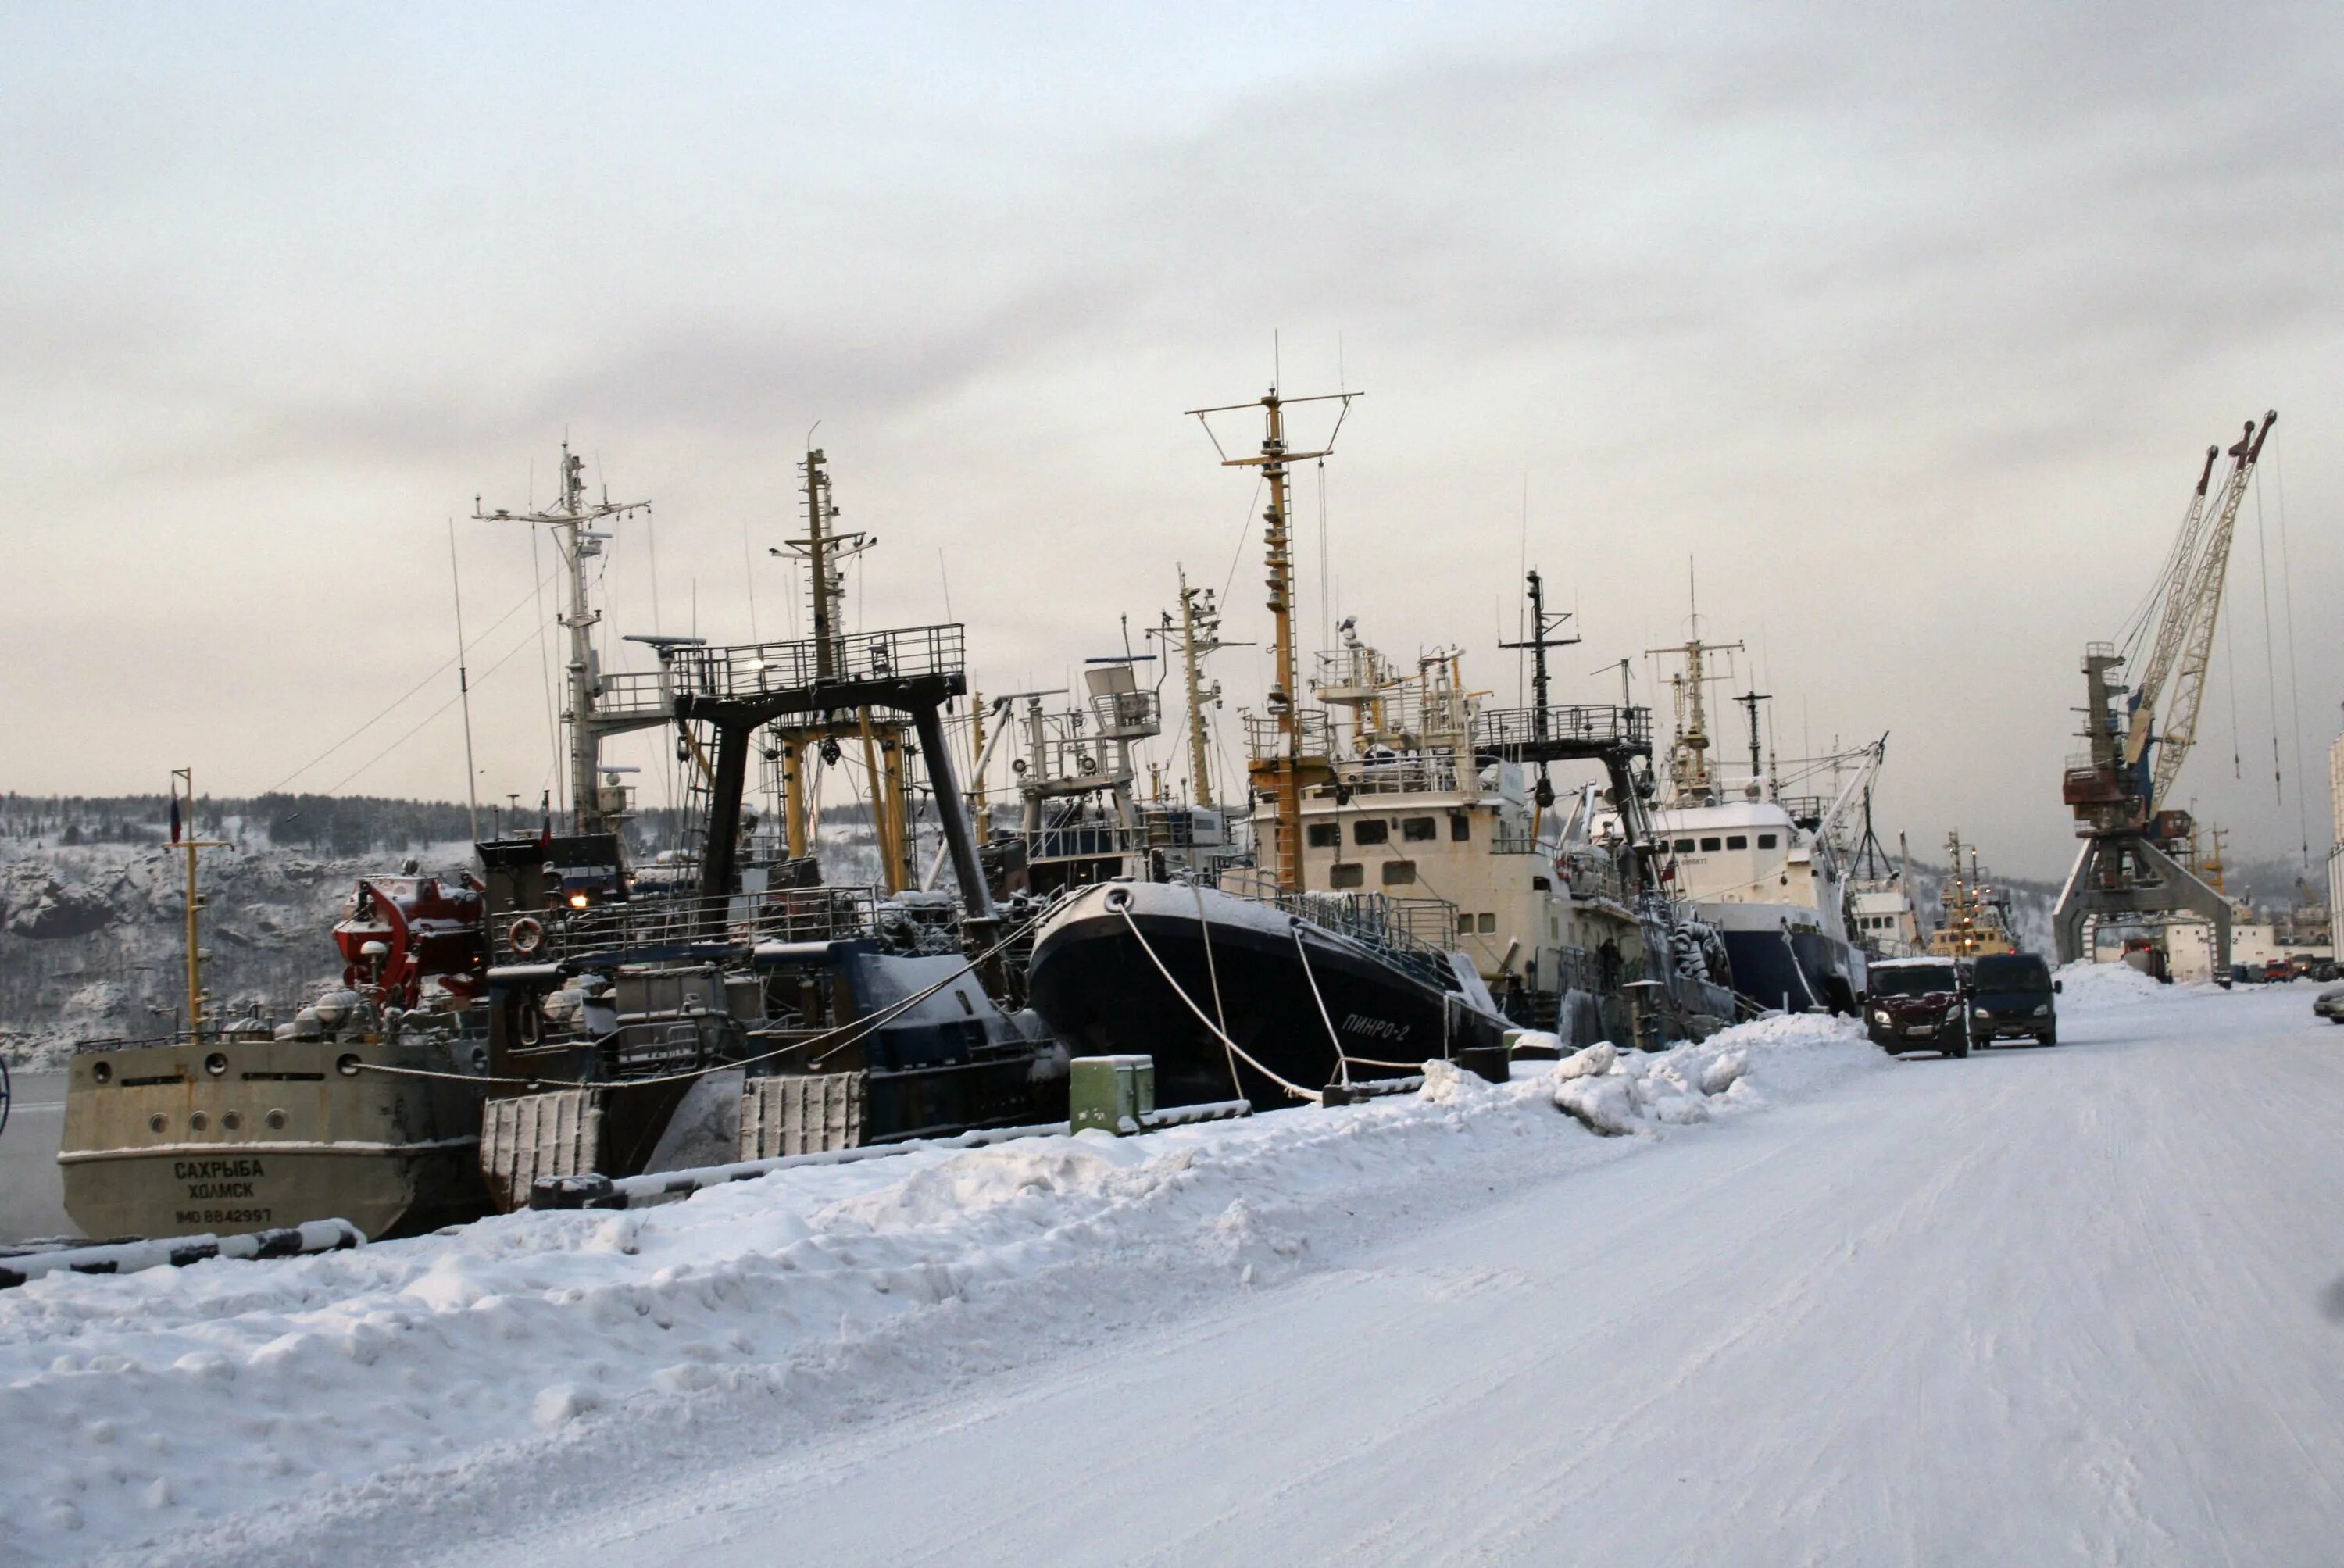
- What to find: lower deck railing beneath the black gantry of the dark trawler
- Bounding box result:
[490,886,881,963]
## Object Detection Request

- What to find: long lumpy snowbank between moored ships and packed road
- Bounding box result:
[0,1017,1878,1561]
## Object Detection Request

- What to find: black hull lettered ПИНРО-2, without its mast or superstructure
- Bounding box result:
[1029,884,1503,1111]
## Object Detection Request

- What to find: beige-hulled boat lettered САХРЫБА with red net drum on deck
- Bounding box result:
[56,769,483,1238]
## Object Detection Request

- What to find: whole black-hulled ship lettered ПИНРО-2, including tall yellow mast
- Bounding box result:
[1029,387,1556,1109]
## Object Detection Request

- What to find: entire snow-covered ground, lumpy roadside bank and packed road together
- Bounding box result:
[0,984,2344,1563]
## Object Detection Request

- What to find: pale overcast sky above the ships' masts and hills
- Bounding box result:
[0,2,2344,874]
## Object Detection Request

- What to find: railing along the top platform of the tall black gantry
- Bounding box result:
[595,621,968,717]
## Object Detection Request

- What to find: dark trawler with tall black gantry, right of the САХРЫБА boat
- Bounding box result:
[464,448,1064,1209]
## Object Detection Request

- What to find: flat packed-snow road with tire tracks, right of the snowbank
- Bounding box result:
[471,987,2344,1568]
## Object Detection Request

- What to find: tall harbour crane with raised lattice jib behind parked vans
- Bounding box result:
[2053,410,2278,973]
